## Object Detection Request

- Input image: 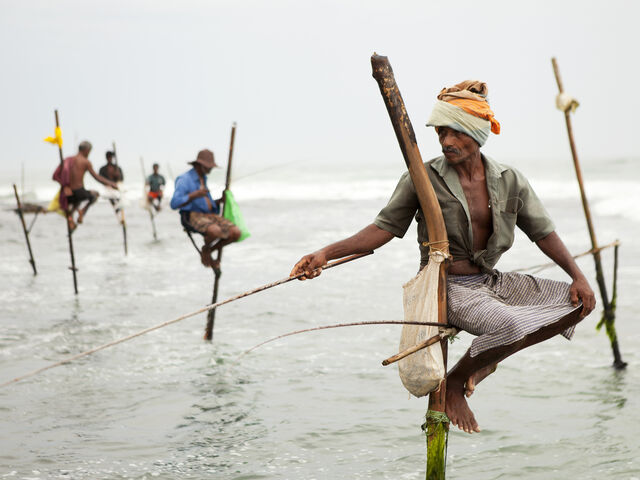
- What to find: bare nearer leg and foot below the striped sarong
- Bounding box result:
[445,309,581,433]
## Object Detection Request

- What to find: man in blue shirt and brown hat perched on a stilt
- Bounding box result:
[171,149,241,268]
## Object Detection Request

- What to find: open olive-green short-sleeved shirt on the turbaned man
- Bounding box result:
[374,155,555,272]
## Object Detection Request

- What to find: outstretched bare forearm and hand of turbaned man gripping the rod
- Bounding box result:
[289,223,393,280]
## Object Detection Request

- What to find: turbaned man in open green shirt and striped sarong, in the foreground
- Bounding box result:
[291,81,595,433]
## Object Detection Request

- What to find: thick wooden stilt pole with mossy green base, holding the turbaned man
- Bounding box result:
[371,53,449,480]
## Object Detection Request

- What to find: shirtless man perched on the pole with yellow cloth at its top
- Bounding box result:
[67,140,118,230]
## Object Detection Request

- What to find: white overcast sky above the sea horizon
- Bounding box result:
[0,0,640,184]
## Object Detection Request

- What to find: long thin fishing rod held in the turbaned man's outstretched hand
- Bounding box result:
[0,251,373,388]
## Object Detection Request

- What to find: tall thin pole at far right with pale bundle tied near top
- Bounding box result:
[551,57,627,369]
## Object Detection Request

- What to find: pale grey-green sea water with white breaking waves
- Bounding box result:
[0,159,640,480]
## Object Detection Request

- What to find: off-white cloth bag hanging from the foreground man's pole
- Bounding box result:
[398,251,446,397]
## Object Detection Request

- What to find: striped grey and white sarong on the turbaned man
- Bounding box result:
[447,271,580,357]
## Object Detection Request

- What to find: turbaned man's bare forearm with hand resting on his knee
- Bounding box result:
[536,232,596,318]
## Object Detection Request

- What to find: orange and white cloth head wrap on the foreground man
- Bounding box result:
[427,80,500,146]
